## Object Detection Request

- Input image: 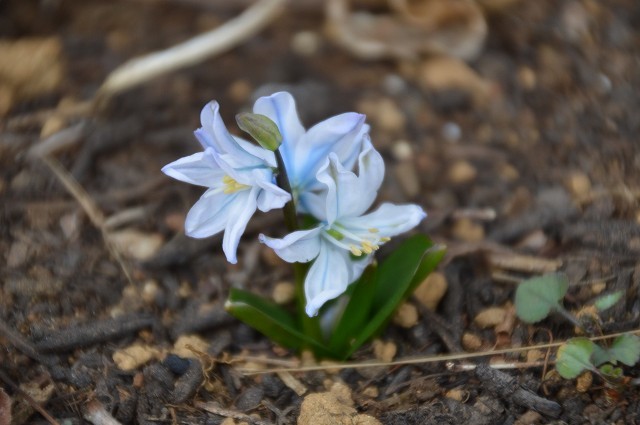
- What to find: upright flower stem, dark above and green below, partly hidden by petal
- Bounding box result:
[274,149,322,342]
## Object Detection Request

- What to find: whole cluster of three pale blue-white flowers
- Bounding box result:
[162,92,426,316]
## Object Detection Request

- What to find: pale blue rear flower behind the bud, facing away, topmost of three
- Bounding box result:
[253,92,369,212]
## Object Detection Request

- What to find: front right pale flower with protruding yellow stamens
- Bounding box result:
[260,142,426,316]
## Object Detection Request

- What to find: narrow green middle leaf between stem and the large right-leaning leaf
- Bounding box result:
[329,265,377,353]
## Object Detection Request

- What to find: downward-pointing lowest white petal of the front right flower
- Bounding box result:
[304,242,350,317]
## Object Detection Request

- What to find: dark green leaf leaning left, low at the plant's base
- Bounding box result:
[225,288,335,357]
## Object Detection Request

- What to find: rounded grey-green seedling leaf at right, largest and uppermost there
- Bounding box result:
[515,274,569,323]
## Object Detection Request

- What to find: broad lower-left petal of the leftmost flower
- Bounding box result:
[184,189,234,238]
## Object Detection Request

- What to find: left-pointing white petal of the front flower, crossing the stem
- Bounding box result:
[259,227,323,263]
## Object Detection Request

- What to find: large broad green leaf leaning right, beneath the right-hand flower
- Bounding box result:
[340,235,445,359]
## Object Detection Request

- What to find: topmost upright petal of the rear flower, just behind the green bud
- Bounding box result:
[253,92,304,171]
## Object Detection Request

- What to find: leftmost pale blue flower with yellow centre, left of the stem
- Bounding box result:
[162,102,291,263]
